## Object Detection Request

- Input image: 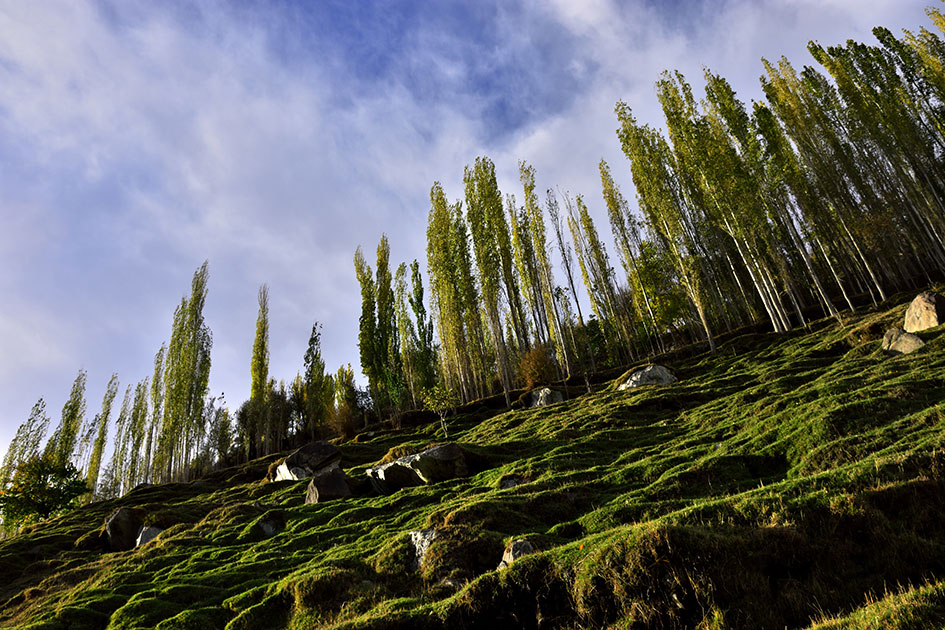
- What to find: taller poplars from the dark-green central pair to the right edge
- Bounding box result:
[355,14,945,412]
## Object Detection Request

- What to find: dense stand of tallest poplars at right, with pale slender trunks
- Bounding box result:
[617,16,945,344]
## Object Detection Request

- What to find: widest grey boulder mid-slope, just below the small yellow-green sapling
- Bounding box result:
[367,442,469,494]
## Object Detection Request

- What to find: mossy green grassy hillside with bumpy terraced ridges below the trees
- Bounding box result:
[0,296,945,629]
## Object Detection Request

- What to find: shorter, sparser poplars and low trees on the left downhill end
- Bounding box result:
[0,262,350,512]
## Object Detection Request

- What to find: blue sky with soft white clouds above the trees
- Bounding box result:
[0,0,933,462]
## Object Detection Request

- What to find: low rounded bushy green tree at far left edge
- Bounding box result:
[0,456,89,530]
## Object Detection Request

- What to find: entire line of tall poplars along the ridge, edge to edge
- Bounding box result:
[0,10,945,508]
